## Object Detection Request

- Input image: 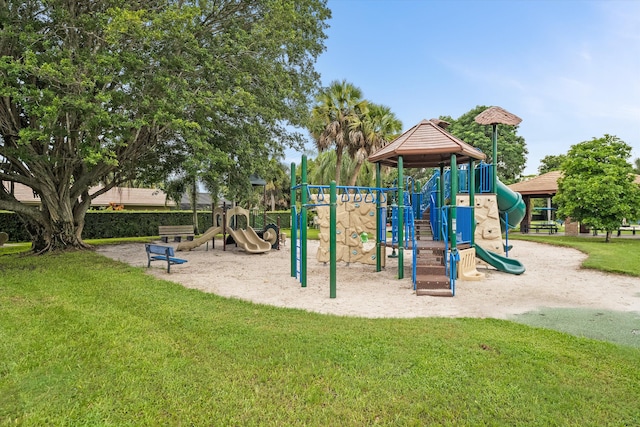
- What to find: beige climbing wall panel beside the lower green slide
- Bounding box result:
[456,194,504,255]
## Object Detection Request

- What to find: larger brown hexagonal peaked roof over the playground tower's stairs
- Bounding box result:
[369,119,486,168]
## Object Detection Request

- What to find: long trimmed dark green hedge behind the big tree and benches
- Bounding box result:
[0,211,291,242]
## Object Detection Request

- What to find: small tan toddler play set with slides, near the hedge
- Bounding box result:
[177,206,279,254]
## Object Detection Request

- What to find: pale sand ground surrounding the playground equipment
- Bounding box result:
[97,240,640,319]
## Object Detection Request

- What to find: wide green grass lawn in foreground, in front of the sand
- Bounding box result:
[0,242,640,426]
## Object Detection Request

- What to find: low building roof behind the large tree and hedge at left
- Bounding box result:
[2,181,176,207]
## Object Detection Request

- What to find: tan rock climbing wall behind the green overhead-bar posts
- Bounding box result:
[312,197,386,266]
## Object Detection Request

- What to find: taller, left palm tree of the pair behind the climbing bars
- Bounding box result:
[309,80,367,184]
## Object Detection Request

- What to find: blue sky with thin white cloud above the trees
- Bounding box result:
[287,0,640,174]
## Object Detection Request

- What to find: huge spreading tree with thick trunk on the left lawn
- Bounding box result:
[0,0,330,251]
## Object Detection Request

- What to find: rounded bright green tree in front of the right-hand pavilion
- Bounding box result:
[554,135,640,242]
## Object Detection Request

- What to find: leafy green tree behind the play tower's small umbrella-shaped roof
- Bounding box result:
[440,105,529,184]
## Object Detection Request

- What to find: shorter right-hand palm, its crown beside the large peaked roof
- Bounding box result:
[347,103,402,185]
